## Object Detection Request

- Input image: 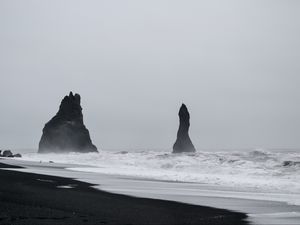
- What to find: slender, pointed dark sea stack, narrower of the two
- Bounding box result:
[173,104,196,153]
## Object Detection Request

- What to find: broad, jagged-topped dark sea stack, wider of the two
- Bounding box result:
[38,92,98,153]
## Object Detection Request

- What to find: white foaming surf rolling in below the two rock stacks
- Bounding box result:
[22,150,300,193]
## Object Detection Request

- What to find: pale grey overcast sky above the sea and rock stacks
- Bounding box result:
[0,0,300,149]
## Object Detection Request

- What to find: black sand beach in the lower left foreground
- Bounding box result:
[0,163,247,225]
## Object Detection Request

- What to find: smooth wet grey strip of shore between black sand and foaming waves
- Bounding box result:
[1,159,300,225]
